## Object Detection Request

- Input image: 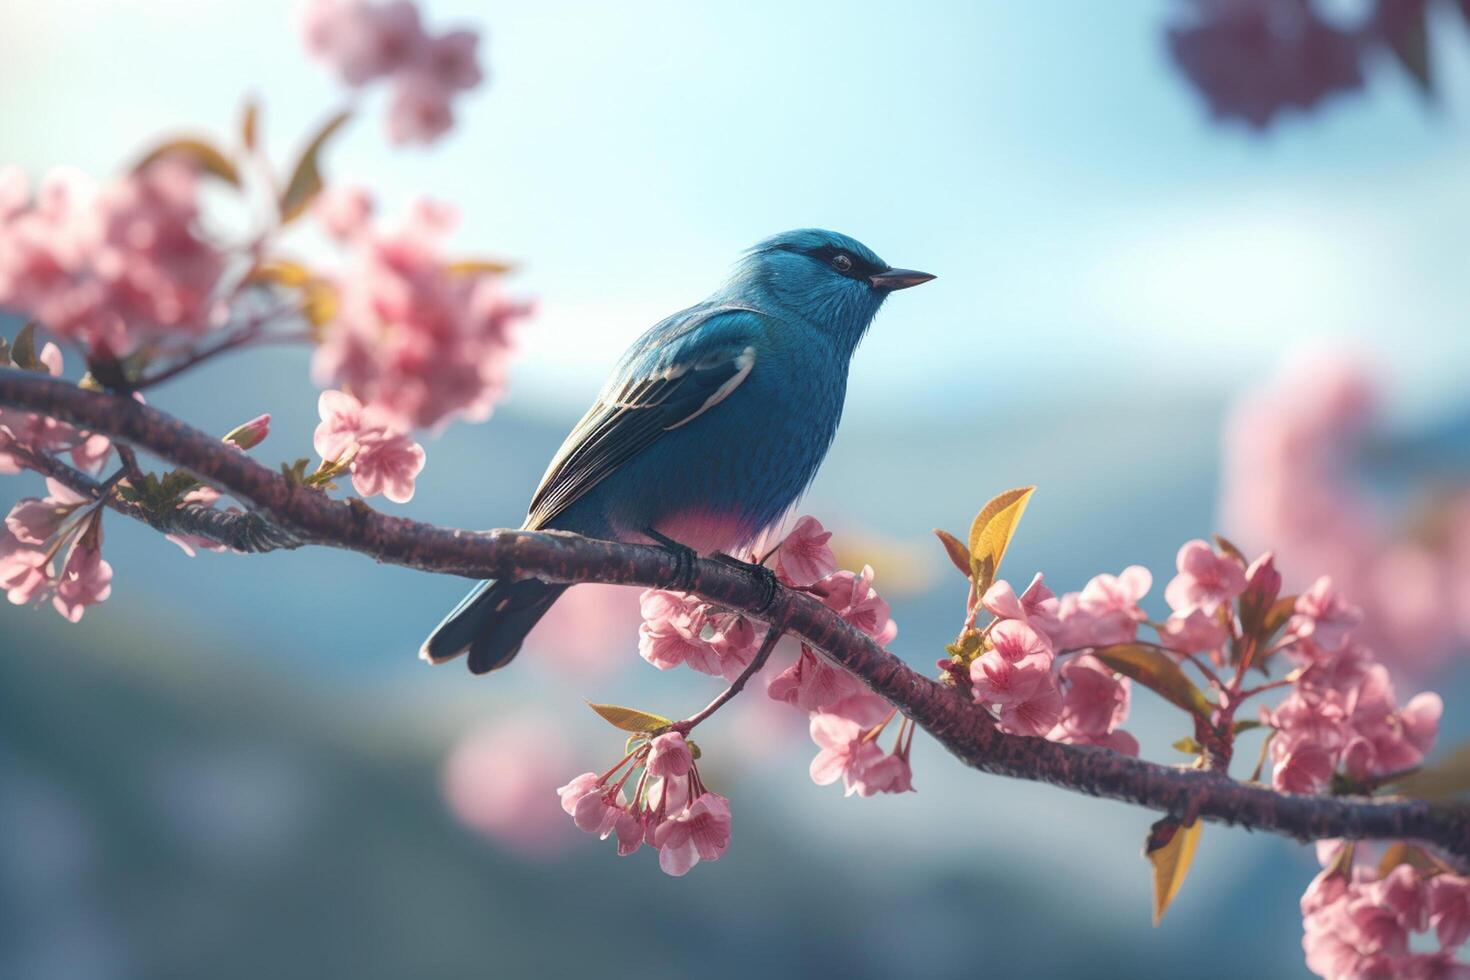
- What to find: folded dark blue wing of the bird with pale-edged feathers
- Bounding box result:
[525,307,764,529]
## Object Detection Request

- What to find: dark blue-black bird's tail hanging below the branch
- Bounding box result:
[419,579,569,674]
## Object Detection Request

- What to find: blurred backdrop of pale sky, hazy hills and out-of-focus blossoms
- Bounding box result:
[0,0,1470,979]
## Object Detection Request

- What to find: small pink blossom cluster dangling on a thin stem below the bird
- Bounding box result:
[557,730,731,876]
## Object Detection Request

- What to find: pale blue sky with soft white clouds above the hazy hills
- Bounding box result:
[0,0,1470,419]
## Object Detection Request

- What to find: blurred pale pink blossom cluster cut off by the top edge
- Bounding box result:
[301,0,484,143]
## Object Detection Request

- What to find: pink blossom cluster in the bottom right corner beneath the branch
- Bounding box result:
[1301,840,1470,980]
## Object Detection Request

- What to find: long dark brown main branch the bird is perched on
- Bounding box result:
[0,369,1470,862]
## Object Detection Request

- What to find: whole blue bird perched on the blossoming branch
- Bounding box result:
[420,228,933,674]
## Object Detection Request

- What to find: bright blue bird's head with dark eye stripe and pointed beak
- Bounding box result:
[729,228,933,345]
